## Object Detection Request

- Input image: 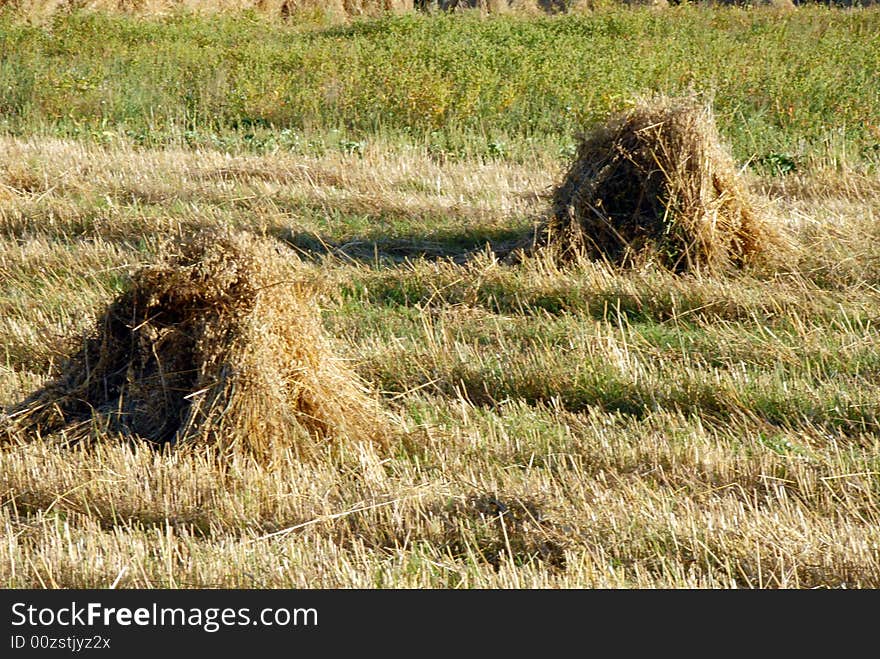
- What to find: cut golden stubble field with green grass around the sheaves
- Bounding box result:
[0,137,880,588]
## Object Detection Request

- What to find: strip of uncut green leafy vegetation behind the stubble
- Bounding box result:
[0,3,880,168]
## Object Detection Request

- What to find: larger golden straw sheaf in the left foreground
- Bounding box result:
[9,233,389,458]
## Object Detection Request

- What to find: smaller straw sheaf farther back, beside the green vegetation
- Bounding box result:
[535,98,783,272]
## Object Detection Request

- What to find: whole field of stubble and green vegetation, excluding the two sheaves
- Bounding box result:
[0,3,880,588]
